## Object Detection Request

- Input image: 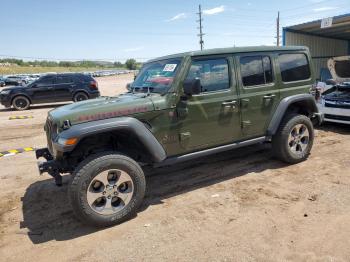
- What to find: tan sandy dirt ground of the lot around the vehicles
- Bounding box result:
[0,75,350,262]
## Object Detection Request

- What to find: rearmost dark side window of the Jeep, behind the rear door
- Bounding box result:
[278,54,311,82]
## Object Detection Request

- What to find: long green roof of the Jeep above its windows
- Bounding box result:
[148,46,308,62]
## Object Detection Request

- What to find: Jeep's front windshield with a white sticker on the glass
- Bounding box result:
[131,58,181,93]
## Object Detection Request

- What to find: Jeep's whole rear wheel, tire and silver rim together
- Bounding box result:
[272,114,314,164]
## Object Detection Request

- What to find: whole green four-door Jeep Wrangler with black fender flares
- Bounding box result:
[36,47,321,226]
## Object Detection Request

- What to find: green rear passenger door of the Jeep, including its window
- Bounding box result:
[235,53,280,138]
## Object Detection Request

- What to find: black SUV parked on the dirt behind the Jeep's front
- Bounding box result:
[0,73,100,110]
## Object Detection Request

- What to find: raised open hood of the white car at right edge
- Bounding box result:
[328,56,350,83]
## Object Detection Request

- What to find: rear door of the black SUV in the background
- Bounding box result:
[55,75,76,102]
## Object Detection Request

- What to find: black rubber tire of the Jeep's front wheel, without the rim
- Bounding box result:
[68,152,146,227]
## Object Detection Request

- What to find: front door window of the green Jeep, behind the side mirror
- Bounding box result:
[187,58,230,92]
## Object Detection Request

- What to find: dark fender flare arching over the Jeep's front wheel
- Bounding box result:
[53,117,166,163]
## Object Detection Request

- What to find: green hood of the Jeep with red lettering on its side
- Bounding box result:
[49,93,155,126]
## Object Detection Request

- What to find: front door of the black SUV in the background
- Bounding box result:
[31,76,55,103]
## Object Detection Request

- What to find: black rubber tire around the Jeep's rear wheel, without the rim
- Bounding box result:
[272,114,314,164]
